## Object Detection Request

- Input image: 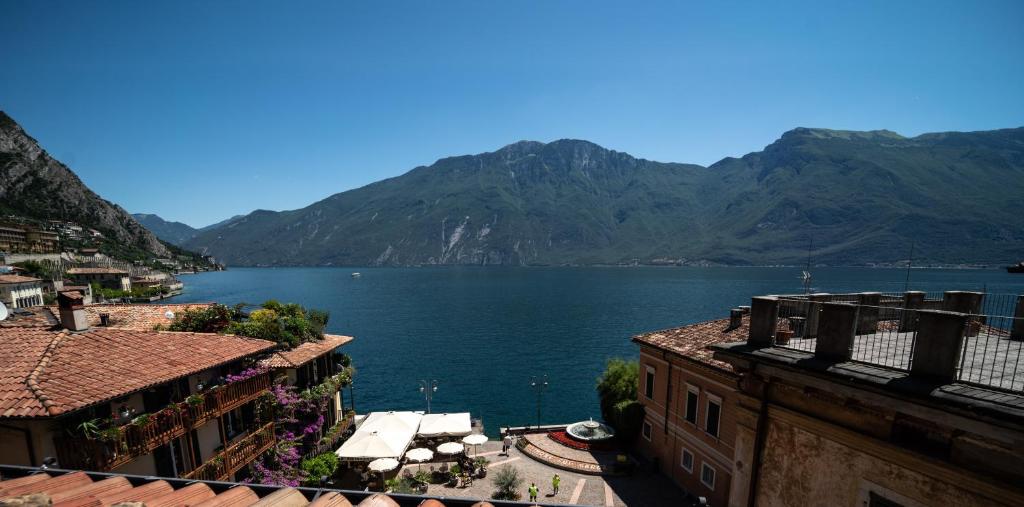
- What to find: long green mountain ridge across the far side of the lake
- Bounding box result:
[184,128,1024,265]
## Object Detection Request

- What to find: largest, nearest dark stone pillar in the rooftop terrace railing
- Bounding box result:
[910,310,967,384]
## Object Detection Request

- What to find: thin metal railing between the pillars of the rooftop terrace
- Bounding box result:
[753,292,1024,393]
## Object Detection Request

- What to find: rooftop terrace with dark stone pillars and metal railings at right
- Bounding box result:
[713,291,1024,417]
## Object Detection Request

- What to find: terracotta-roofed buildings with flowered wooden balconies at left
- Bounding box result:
[0,297,351,480]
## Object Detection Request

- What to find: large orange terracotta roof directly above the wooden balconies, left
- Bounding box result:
[0,328,275,418]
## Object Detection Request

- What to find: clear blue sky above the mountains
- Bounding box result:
[0,0,1024,226]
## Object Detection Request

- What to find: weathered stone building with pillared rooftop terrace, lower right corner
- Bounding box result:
[712,292,1024,507]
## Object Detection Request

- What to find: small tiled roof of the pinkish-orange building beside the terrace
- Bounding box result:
[633,315,751,372]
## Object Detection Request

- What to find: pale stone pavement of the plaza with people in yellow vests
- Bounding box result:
[406,441,687,507]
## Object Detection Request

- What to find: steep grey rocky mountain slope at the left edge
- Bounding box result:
[0,112,169,257]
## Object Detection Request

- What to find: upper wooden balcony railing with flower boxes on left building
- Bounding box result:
[54,374,270,471]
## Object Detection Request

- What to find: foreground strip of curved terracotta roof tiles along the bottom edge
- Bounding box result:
[0,470,523,507]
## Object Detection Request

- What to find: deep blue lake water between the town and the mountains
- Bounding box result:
[172,267,1024,434]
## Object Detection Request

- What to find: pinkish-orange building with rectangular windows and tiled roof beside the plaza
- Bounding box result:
[633,313,748,505]
